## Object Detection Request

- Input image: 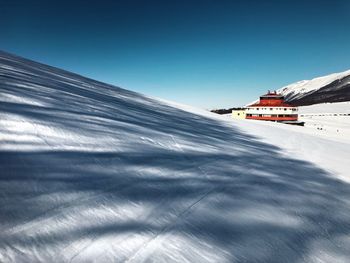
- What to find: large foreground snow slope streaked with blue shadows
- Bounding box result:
[0,52,350,263]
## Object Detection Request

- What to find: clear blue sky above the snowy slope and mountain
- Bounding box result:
[0,0,350,109]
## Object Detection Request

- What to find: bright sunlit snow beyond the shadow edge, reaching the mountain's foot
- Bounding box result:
[225,102,350,183]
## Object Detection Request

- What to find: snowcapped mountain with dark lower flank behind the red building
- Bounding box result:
[277,70,350,106]
